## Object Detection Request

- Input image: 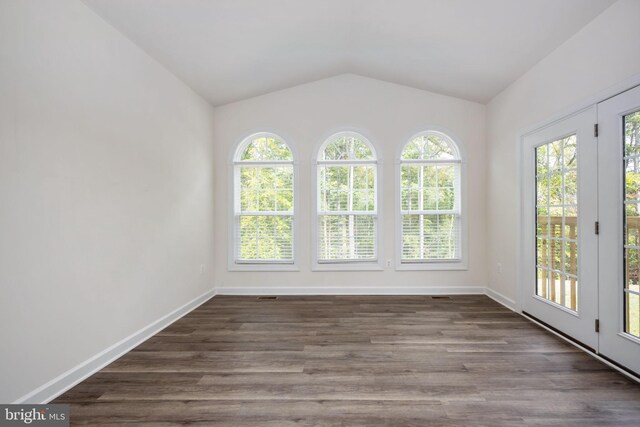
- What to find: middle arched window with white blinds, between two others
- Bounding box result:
[317,132,378,263]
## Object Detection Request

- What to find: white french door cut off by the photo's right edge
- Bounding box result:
[598,87,640,374]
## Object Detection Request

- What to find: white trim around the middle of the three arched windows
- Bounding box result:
[311,130,384,271]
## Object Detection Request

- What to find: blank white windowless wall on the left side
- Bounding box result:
[0,0,214,403]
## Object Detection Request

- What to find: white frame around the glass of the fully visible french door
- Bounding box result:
[519,106,598,351]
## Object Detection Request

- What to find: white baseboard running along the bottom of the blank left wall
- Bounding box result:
[13,289,215,403]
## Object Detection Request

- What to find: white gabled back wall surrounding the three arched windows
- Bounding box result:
[214,75,486,293]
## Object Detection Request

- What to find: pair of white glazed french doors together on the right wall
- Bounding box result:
[520,86,640,375]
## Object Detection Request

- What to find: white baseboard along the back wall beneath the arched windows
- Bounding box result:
[216,286,486,295]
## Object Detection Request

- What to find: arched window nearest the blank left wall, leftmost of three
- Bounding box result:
[233,133,295,264]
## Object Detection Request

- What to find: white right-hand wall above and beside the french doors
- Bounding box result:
[487,0,640,299]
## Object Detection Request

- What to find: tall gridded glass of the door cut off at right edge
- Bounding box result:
[623,111,640,337]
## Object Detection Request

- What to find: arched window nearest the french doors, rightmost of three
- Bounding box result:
[400,131,461,263]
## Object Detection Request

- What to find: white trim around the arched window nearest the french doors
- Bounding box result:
[395,126,469,271]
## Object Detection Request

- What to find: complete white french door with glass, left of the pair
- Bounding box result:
[520,106,598,351]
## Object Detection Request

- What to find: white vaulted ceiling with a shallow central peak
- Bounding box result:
[84,0,614,106]
